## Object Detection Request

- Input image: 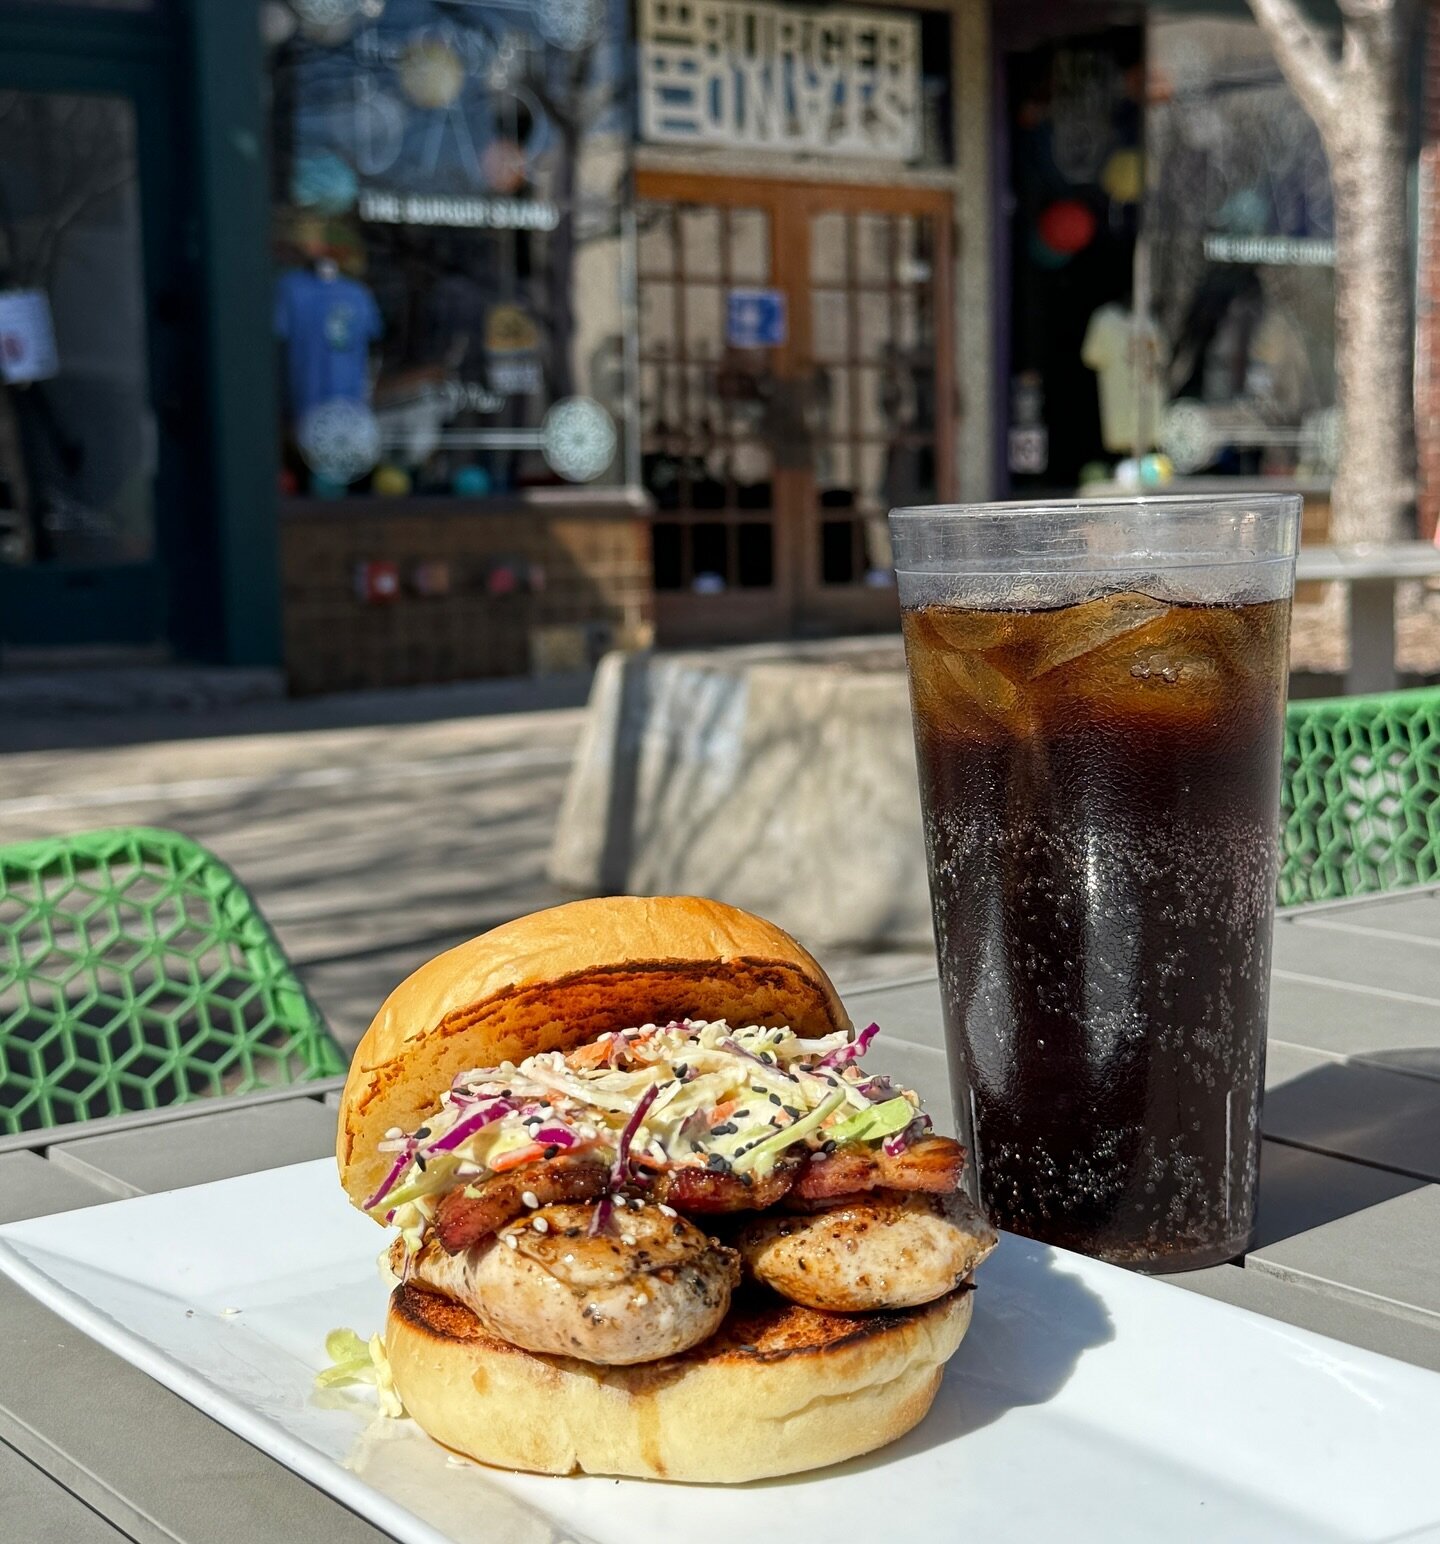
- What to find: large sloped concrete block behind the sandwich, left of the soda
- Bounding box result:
[549,639,931,946]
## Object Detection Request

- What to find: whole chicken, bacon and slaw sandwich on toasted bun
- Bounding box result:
[336,897,995,1482]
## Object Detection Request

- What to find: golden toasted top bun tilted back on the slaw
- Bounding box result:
[335,896,850,1206]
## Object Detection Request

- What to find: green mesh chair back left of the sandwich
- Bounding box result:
[0,829,344,1132]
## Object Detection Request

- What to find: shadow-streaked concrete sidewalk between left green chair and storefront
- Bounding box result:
[0,681,928,1047]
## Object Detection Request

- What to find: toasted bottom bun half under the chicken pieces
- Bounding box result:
[386,1286,971,1482]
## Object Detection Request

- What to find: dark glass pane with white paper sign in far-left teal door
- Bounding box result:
[0,91,156,567]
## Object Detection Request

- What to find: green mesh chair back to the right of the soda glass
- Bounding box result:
[1278,687,1440,906]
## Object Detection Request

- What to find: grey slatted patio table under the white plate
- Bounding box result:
[0,885,1440,1544]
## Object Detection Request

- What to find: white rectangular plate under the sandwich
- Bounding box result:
[0,1160,1440,1544]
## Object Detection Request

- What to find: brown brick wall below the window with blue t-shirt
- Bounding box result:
[281,496,651,693]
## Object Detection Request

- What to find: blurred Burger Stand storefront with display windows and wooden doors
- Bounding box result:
[0,0,1413,690]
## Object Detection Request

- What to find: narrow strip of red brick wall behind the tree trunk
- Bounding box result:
[1415,0,1440,537]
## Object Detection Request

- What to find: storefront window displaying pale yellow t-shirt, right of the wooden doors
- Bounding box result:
[1006,9,1337,493]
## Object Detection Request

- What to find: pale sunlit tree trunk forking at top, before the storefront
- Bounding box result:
[1250,0,1415,543]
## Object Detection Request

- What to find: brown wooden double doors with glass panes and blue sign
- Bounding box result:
[637,173,954,644]
